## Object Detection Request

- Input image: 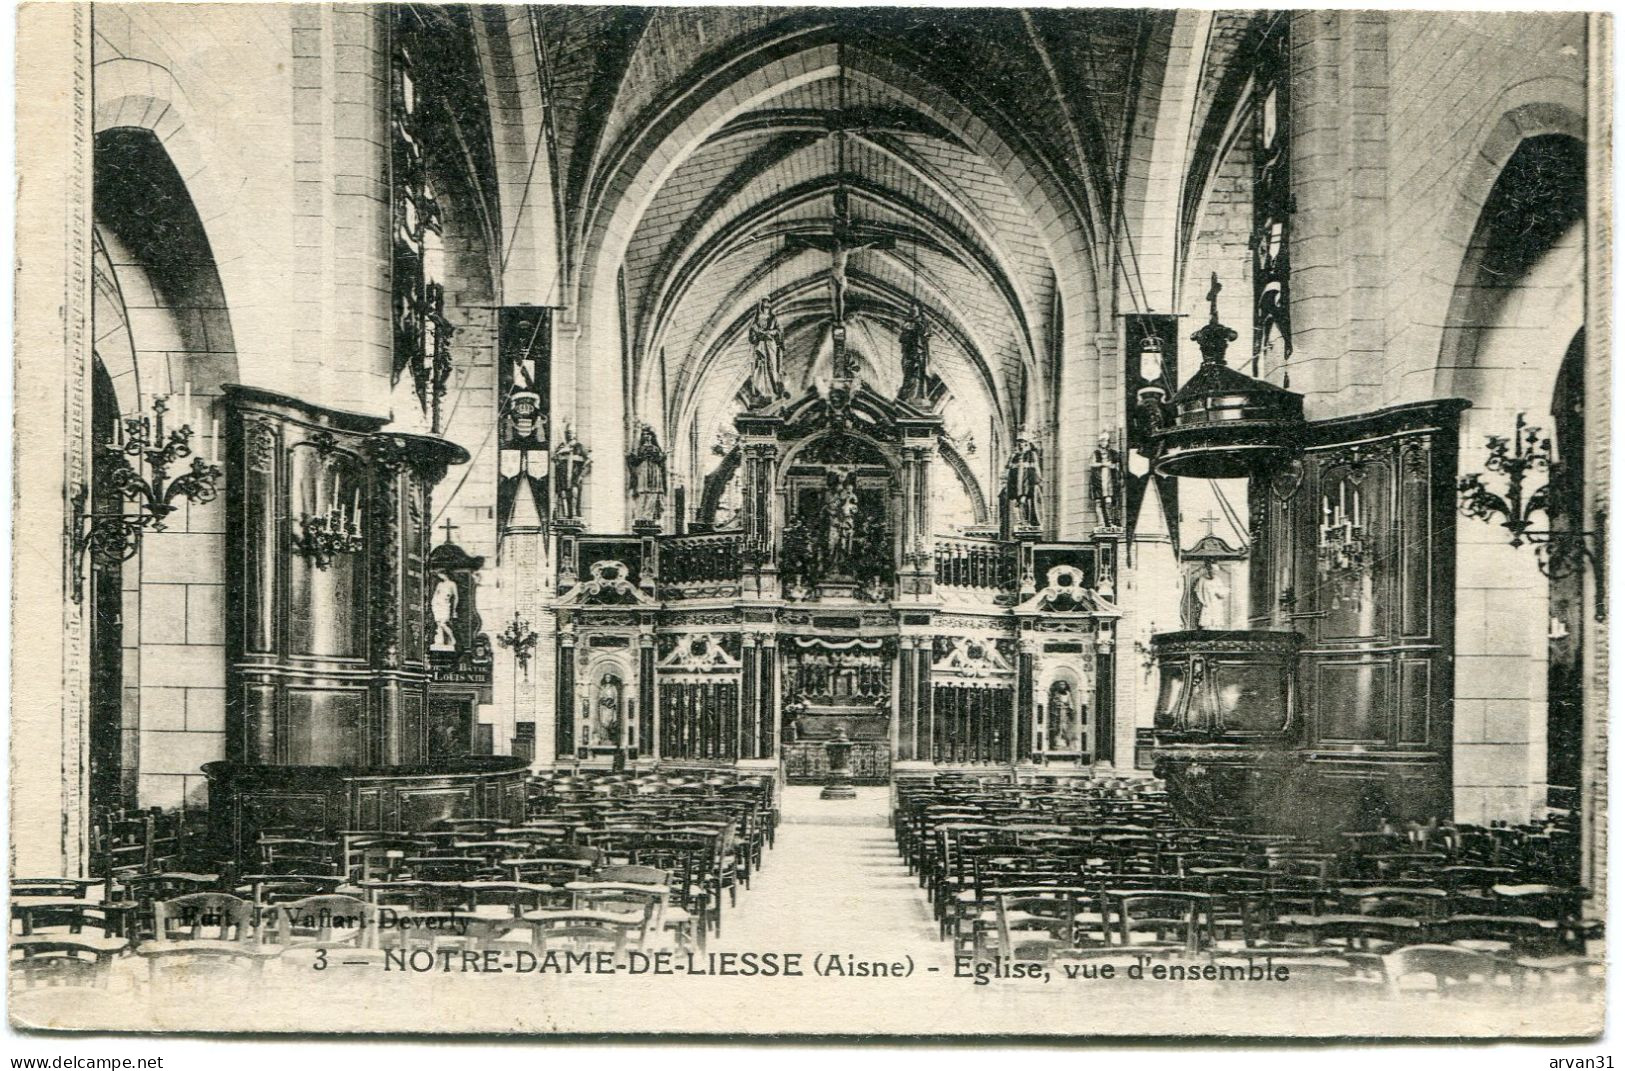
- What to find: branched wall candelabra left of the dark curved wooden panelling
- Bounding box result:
[70,384,221,601]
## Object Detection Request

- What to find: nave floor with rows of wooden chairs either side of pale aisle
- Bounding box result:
[11,770,1602,1035]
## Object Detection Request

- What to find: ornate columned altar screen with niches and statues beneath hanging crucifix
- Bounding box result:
[554,327,1118,783]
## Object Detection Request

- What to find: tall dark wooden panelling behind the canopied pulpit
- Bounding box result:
[1251,401,1464,757]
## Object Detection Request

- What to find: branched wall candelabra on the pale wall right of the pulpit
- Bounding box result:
[1456,413,1607,621]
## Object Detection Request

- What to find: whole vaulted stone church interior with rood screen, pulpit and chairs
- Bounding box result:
[11,3,1609,1027]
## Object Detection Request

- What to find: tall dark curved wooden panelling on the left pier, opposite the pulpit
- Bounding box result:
[226,387,466,767]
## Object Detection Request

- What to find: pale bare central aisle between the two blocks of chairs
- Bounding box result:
[710,785,943,959]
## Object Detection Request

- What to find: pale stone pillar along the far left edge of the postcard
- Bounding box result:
[11,3,93,874]
